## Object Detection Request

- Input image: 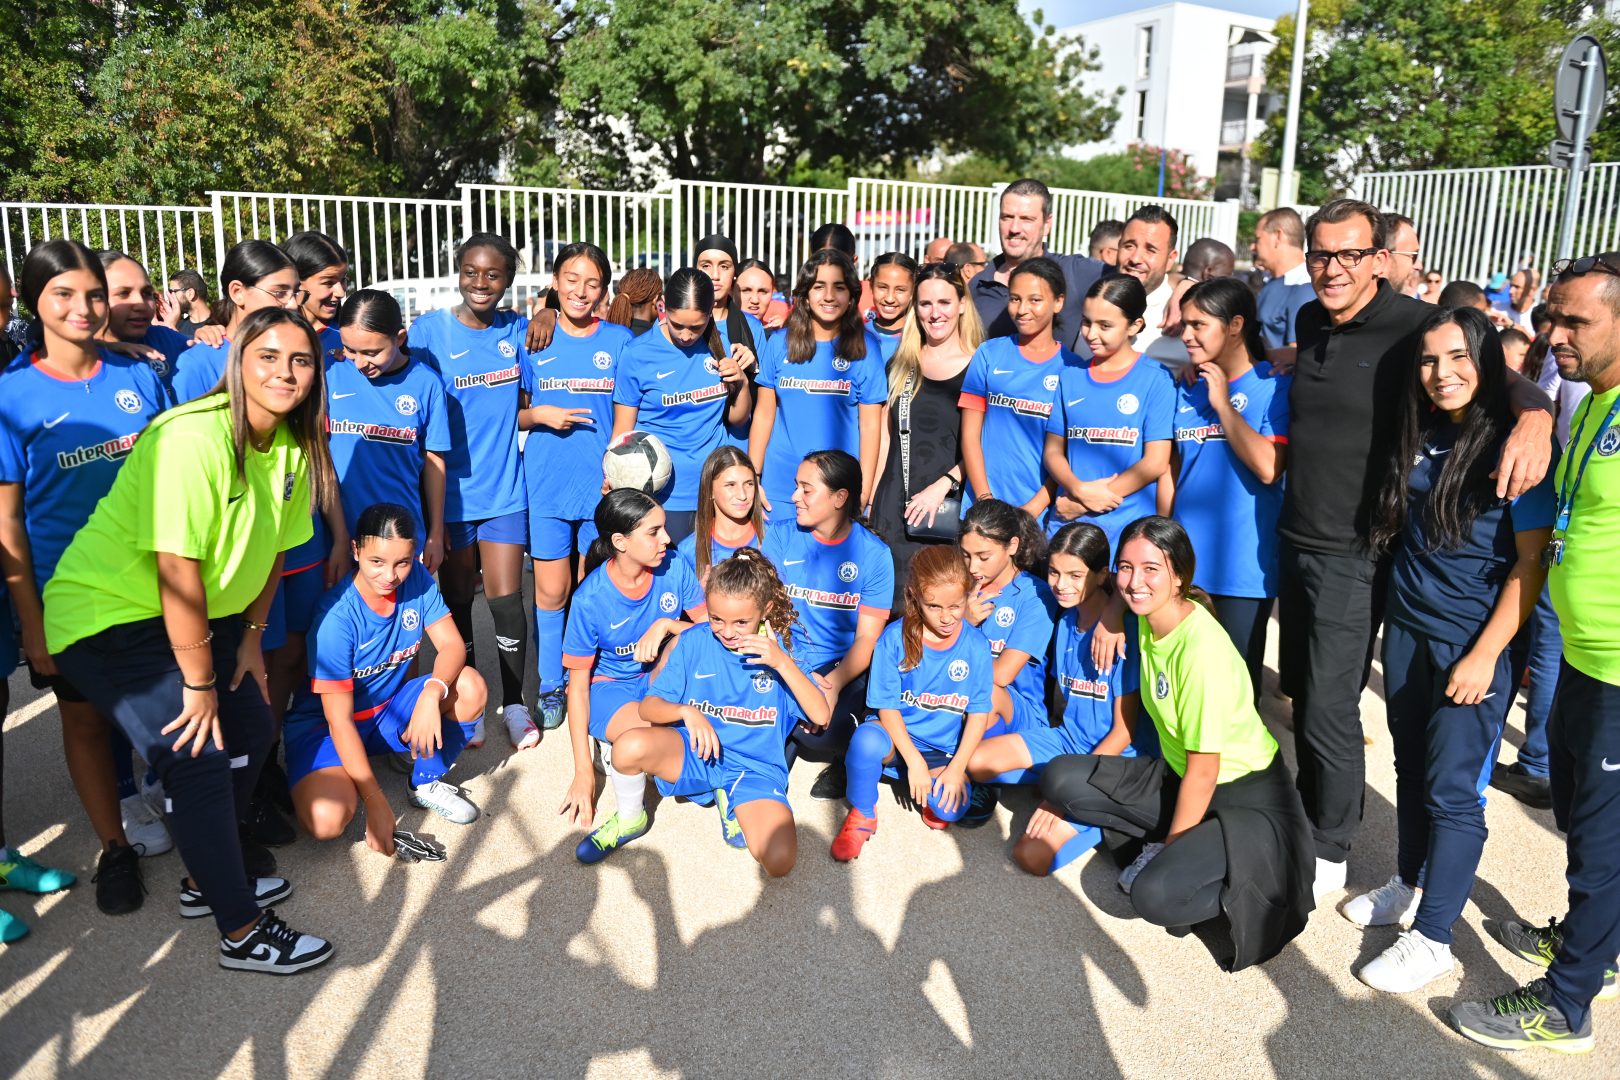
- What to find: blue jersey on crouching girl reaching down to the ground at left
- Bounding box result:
[287,562,450,721]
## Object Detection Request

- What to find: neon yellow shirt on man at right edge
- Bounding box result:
[1547,387,1620,685]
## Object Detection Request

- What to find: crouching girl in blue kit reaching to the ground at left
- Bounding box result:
[285,502,488,855]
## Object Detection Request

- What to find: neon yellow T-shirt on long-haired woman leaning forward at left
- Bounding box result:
[44,393,313,653]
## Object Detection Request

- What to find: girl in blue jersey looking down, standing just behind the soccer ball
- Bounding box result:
[612,267,753,541]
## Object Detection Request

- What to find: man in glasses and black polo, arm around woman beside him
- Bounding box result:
[1277,199,1552,897]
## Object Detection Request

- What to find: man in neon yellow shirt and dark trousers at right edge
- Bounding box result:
[1452,251,1620,1052]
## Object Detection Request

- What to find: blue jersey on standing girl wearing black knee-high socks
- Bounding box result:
[408,309,528,521]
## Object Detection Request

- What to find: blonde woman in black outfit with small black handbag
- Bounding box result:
[872,262,985,596]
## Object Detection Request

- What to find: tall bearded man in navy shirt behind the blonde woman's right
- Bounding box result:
[967,180,1108,359]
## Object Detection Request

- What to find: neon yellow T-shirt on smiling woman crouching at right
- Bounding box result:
[1137,604,1277,784]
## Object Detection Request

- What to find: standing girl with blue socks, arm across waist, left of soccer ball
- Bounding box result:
[507,243,630,750]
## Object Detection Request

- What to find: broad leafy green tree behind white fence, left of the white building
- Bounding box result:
[561,0,1118,183]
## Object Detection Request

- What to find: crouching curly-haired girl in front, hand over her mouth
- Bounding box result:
[614,547,831,878]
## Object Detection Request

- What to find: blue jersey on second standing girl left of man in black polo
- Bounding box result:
[1047,356,1176,547]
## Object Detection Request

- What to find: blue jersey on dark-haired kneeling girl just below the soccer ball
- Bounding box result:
[562,551,708,678]
